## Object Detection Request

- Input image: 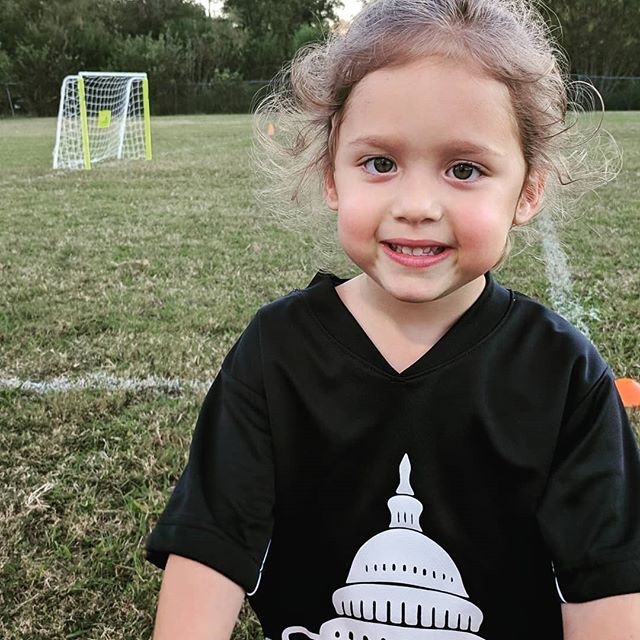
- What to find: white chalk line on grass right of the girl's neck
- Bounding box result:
[540,215,593,338]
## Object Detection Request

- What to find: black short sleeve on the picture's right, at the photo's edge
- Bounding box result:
[537,370,640,602]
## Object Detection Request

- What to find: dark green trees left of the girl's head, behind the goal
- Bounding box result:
[0,0,339,115]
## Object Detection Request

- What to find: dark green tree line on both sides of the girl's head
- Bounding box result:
[0,0,640,115]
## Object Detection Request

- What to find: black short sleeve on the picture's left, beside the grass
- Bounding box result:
[146,319,274,592]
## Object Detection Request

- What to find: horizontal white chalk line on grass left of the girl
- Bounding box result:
[0,373,211,394]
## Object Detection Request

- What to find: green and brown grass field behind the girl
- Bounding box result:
[0,113,640,640]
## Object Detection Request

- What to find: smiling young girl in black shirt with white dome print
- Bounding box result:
[148,0,640,640]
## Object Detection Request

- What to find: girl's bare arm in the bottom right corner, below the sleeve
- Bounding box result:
[562,593,640,640]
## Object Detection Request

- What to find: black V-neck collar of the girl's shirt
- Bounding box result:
[305,272,514,379]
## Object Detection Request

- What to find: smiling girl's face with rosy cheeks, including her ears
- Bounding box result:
[325,57,541,302]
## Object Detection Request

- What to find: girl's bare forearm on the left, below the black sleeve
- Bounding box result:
[153,555,244,640]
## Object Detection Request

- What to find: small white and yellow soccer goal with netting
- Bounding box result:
[53,71,151,169]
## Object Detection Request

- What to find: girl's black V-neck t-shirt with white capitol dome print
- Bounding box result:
[147,275,640,640]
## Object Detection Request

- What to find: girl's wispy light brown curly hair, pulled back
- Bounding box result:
[254,0,615,268]
